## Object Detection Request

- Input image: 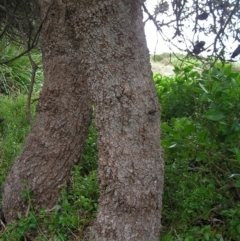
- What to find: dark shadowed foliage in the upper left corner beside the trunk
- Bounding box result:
[0,0,41,64]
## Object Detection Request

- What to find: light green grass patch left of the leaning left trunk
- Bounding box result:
[0,95,35,184]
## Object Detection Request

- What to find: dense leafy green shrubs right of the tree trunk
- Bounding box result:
[155,65,240,241]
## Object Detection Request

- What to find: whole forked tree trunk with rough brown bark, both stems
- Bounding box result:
[3,0,163,241]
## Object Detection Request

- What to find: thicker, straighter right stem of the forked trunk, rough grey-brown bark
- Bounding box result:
[79,0,163,241]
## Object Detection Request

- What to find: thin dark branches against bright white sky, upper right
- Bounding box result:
[143,0,240,60]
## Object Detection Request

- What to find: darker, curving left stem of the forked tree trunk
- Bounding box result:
[2,0,91,222]
